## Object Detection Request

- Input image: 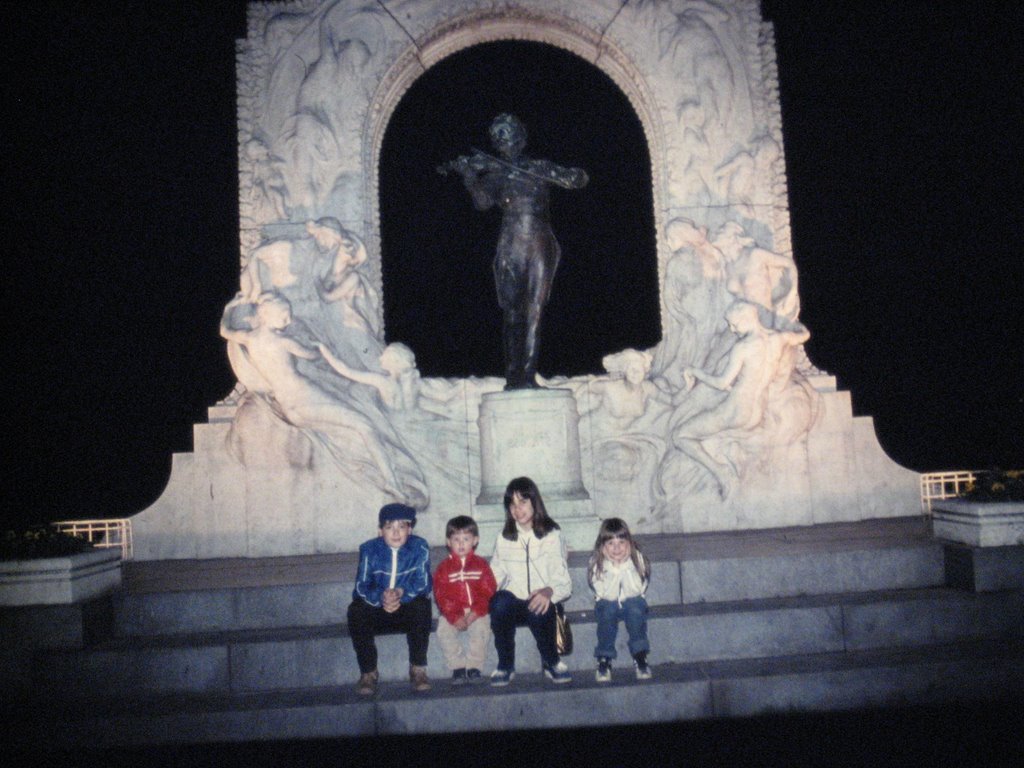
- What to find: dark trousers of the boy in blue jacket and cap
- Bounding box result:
[348,595,430,674]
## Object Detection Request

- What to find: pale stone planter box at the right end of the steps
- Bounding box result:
[932,499,1024,547]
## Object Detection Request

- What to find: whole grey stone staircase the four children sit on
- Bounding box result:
[5,518,1024,746]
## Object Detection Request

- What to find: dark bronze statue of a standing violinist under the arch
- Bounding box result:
[437,114,589,389]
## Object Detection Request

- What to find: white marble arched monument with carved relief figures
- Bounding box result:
[133,0,918,559]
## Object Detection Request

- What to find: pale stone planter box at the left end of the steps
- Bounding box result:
[0,549,121,605]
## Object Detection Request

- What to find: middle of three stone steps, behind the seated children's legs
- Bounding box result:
[35,588,1024,699]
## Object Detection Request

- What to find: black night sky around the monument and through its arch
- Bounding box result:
[0,0,1024,536]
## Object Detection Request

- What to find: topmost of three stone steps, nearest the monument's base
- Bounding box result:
[114,518,945,637]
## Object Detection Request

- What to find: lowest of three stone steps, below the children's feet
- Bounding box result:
[16,640,1024,754]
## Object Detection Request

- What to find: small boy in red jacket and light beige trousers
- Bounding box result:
[434,515,498,685]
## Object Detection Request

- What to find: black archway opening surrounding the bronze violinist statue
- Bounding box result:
[380,42,660,377]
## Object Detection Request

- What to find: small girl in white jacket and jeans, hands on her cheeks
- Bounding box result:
[587,517,651,683]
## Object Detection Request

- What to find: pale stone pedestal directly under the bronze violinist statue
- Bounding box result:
[474,389,598,553]
